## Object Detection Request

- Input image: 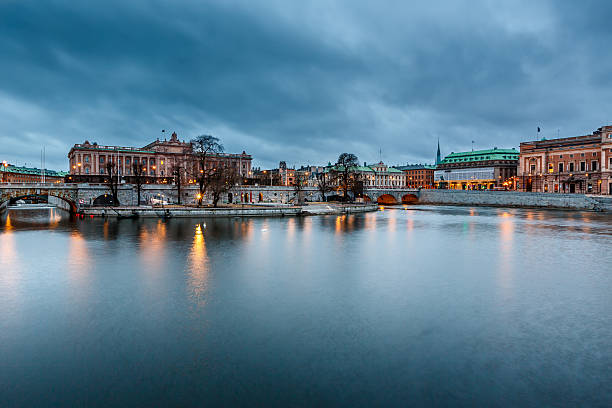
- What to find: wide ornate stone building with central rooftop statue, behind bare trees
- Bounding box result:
[67,133,252,183]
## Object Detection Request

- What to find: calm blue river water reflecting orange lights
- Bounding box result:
[0,206,612,407]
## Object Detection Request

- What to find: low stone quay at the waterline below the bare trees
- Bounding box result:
[78,203,378,218]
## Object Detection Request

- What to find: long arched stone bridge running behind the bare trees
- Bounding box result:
[0,183,419,212]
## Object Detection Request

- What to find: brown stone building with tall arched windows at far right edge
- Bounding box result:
[518,126,612,194]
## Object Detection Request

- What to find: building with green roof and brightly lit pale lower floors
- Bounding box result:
[434,148,519,190]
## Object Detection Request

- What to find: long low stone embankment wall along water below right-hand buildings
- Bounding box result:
[418,190,606,211]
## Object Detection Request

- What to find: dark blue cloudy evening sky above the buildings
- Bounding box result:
[0,0,612,170]
